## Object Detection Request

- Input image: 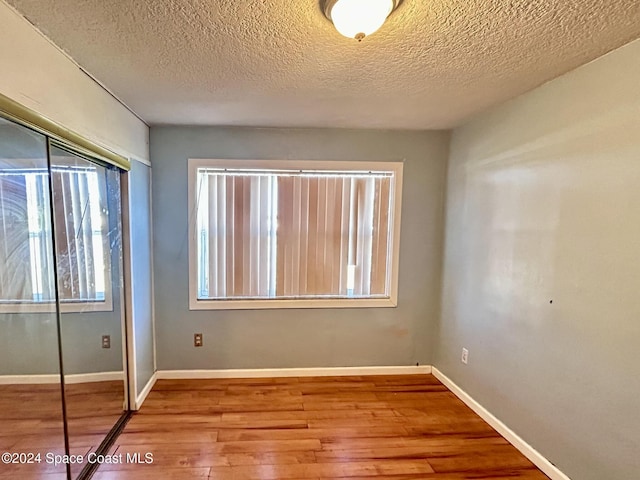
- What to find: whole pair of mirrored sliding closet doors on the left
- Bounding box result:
[0,118,128,479]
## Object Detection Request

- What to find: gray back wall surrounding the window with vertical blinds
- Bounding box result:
[150,127,449,370]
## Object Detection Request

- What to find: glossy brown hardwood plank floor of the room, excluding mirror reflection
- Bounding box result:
[94,375,547,480]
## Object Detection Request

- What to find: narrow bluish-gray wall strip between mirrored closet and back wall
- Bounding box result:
[129,162,155,394]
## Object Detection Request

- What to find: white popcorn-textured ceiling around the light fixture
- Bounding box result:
[5,0,640,129]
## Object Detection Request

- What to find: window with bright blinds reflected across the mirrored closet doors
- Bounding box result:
[0,165,112,311]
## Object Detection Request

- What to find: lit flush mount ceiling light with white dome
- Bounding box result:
[323,0,402,41]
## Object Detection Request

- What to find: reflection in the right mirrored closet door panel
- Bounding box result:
[50,145,126,476]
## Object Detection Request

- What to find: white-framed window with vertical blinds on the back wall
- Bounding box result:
[189,159,402,309]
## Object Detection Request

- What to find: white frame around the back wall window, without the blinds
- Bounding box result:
[187,158,403,310]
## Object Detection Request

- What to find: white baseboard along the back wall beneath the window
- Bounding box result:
[156,365,431,380]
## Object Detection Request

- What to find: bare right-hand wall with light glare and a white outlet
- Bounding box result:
[435,41,640,480]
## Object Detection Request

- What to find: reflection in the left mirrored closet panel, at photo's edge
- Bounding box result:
[0,118,66,480]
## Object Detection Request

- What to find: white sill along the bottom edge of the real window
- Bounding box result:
[189,298,398,310]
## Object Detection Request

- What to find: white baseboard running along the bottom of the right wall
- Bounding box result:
[432,367,571,480]
